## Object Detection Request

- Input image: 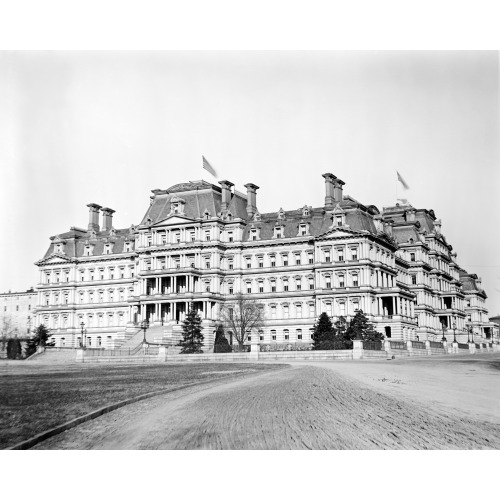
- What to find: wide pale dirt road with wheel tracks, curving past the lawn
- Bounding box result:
[37,357,500,449]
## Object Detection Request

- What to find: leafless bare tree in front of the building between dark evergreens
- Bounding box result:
[220,293,264,346]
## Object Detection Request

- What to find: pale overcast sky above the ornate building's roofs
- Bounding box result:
[0,51,500,315]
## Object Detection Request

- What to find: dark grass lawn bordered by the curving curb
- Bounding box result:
[0,361,284,448]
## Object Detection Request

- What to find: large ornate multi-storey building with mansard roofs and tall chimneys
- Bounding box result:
[36,173,498,348]
